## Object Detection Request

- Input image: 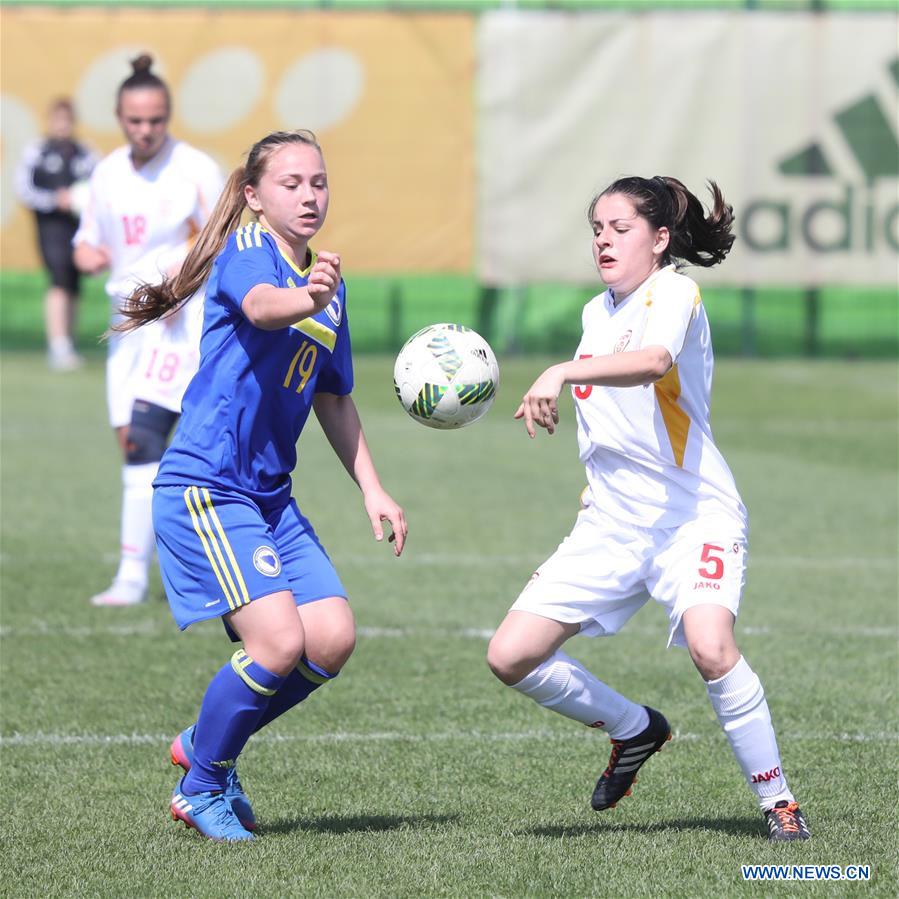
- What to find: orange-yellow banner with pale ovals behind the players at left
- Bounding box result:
[0,7,474,274]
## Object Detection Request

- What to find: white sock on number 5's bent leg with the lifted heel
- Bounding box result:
[512,650,649,740]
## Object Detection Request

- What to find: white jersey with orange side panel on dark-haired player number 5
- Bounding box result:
[573,265,748,530]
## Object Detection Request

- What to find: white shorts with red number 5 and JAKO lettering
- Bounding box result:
[512,492,747,646]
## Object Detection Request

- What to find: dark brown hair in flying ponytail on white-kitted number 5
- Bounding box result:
[587,175,734,268]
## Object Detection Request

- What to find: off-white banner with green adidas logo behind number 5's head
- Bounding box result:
[477,11,899,286]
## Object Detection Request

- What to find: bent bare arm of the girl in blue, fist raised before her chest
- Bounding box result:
[240,252,340,331]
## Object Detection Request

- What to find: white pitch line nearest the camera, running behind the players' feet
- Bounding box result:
[0,730,899,748]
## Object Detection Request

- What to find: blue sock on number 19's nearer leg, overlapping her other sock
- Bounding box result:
[183,649,285,795]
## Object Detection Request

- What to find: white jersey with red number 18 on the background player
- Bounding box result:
[73,138,223,320]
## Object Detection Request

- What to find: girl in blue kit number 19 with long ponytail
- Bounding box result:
[118,131,406,840]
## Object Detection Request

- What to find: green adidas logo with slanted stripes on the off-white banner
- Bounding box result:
[739,58,899,254]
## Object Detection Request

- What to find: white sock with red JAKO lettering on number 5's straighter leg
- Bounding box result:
[706,656,793,811]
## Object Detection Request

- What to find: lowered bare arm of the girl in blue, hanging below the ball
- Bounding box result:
[312,393,408,556]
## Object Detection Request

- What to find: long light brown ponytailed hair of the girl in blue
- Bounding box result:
[113,130,321,331]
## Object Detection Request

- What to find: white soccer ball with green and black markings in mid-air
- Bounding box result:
[393,324,499,430]
